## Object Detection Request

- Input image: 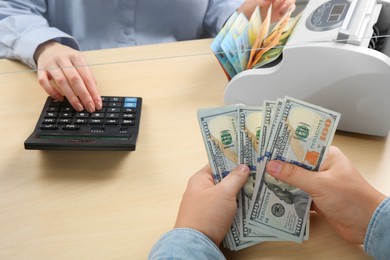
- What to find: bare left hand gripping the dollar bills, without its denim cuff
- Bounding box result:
[175,165,249,246]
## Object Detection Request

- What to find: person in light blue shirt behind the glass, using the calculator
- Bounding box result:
[0,0,295,112]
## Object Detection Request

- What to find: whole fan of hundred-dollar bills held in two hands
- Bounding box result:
[198,97,340,250]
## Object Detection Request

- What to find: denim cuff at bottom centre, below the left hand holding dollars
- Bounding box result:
[148,228,225,260]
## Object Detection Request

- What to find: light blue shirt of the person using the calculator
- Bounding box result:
[0,0,243,68]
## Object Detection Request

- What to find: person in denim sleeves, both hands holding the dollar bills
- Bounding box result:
[149,147,390,260]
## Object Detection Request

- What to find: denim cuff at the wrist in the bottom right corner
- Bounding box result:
[364,197,390,260]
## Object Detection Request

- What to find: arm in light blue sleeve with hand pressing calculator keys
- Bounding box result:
[0,0,101,112]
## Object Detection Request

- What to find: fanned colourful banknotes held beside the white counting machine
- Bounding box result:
[211,5,300,79]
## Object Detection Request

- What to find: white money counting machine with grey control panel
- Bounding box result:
[224,0,390,136]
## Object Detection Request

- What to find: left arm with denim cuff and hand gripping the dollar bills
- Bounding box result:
[149,165,249,259]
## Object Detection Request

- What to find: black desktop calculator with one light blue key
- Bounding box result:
[24,96,142,151]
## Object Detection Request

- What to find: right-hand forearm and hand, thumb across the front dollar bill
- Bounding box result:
[266,147,390,254]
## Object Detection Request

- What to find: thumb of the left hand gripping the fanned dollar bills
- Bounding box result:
[220,164,250,195]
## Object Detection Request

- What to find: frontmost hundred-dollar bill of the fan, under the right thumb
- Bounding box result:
[248,97,340,242]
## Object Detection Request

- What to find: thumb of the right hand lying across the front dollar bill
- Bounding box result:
[266,161,316,194]
